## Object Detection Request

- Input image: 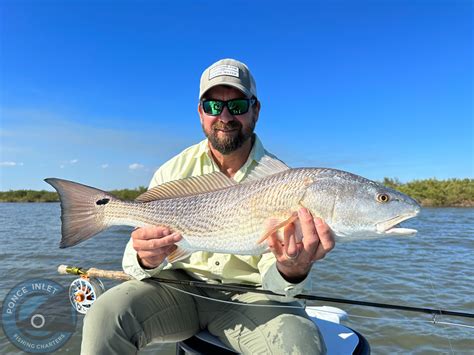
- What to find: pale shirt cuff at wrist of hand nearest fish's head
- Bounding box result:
[258,253,311,302]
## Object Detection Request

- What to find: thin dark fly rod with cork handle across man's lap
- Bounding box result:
[58,265,474,318]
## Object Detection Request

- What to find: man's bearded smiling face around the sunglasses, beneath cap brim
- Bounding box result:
[198,86,260,155]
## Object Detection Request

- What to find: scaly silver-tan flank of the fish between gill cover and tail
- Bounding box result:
[106,171,312,254]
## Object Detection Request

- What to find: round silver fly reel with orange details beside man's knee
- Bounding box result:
[69,276,105,314]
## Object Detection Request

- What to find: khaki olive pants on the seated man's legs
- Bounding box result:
[81,270,325,355]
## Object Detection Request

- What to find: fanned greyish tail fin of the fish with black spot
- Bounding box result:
[44,178,118,248]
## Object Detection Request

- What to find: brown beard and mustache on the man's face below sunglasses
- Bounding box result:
[203,119,255,155]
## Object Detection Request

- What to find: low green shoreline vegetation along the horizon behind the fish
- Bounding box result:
[0,178,474,207]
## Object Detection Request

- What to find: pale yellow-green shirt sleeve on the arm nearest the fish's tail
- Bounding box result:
[122,169,167,280]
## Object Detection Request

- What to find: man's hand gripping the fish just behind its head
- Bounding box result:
[268,208,335,283]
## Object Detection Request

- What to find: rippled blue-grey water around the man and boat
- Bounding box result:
[0,203,474,354]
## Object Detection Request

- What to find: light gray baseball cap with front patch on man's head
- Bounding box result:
[199,58,257,99]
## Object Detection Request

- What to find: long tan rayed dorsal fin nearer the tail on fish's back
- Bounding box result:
[136,171,237,202]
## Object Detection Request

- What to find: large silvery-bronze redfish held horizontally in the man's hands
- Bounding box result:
[45,158,421,261]
